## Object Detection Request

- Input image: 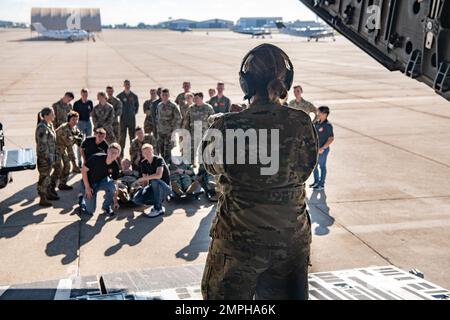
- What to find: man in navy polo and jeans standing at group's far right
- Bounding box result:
[309,107,334,191]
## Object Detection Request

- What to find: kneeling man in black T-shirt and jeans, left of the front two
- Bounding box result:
[80,143,121,216]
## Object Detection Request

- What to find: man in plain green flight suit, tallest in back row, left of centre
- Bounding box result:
[117,80,139,155]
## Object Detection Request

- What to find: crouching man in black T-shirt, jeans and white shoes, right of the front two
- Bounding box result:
[133,143,172,218]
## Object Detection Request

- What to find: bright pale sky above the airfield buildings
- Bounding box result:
[0,0,316,25]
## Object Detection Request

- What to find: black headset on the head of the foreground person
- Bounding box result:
[239,43,294,100]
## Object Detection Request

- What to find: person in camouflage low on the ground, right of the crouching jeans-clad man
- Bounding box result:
[169,157,200,196]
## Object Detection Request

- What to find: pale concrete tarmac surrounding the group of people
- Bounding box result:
[0,29,450,288]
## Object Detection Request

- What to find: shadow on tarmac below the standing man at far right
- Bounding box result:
[308,190,334,236]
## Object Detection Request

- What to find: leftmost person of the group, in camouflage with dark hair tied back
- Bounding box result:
[35,108,59,207]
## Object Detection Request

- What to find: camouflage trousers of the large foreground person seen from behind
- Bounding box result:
[202,239,310,300]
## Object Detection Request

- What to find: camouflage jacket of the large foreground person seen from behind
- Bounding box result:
[202,103,318,247]
